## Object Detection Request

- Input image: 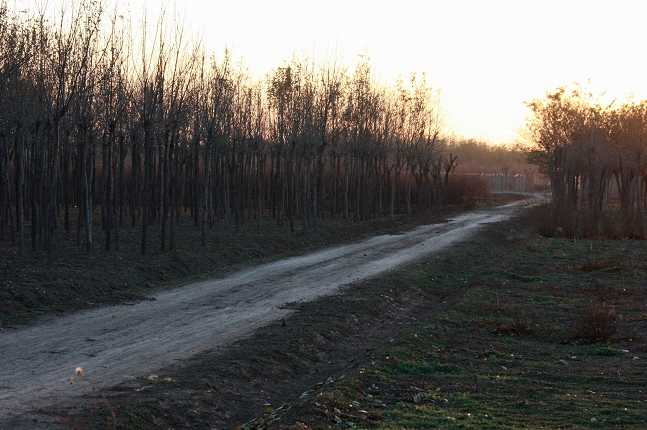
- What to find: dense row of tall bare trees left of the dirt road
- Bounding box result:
[0,0,456,263]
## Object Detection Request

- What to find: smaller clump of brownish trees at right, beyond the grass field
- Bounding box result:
[526,84,647,238]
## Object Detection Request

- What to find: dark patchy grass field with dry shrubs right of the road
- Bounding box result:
[252,215,647,429]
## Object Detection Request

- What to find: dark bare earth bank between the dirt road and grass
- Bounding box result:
[91,277,456,429]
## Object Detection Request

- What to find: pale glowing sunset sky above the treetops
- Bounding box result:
[20,0,647,143]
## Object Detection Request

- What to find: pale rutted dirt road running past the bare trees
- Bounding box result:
[0,204,519,428]
